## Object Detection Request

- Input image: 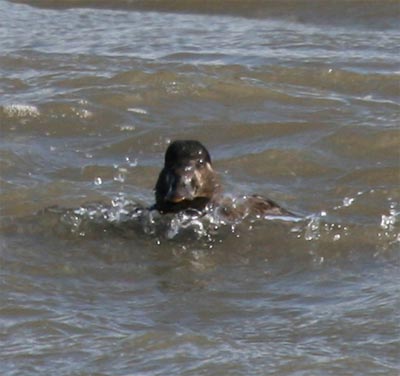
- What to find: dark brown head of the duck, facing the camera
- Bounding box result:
[155,140,220,213]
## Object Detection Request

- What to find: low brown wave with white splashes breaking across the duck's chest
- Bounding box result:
[2,192,400,262]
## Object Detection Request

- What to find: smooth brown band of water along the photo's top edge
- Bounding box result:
[12,0,398,29]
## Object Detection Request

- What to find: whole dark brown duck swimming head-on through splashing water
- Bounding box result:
[153,140,293,217]
